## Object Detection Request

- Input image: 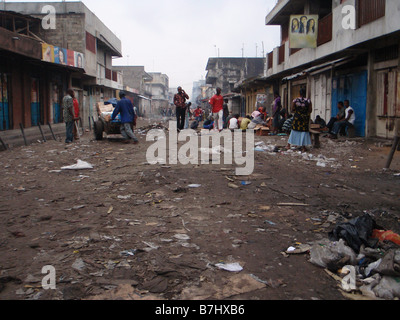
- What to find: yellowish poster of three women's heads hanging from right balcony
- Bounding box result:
[289,15,318,49]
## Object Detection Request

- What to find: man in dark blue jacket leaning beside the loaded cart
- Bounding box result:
[111,91,139,144]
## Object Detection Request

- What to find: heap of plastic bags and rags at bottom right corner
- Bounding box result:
[291,213,400,300]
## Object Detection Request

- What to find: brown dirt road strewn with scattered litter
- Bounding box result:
[0,119,400,300]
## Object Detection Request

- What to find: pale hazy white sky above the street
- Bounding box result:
[6,0,280,93]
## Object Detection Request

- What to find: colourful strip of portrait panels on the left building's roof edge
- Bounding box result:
[42,43,85,69]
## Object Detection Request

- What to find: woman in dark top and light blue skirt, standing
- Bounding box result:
[287,88,312,152]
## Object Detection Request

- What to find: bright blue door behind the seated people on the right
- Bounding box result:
[332,71,368,137]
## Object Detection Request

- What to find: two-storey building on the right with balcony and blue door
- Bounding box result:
[257,0,400,138]
